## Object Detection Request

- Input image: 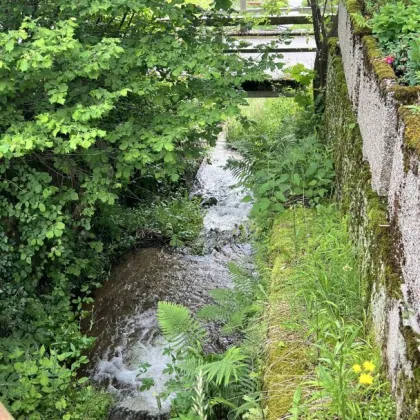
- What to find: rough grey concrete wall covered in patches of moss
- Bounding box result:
[326,34,420,420]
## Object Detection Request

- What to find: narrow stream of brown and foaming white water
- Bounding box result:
[90,133,251,420]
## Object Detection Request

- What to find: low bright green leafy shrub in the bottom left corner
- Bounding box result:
[0,336,111,420]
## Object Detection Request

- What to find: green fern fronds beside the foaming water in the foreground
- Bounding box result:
[158,265,262,420]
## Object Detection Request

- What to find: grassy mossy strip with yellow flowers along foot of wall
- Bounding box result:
[269,208,395,420]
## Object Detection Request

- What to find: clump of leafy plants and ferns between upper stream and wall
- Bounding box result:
[228,99,334,228]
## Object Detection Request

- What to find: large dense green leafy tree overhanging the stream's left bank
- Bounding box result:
[0,0,274,418]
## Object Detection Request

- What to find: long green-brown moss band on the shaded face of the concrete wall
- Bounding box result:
[325,41,401,297]
